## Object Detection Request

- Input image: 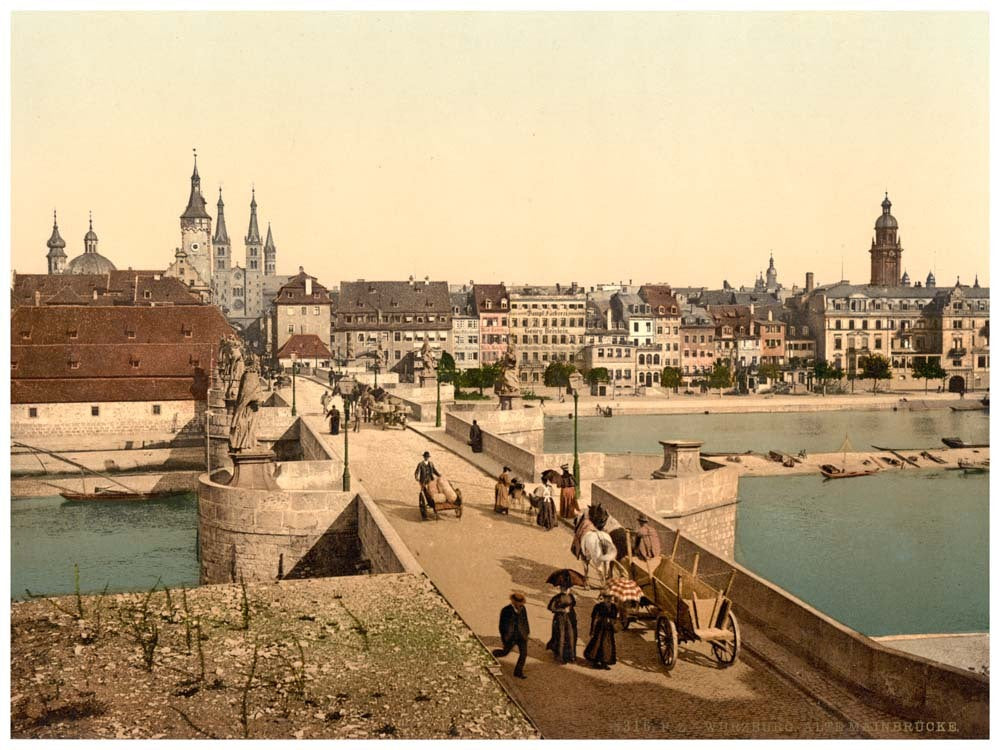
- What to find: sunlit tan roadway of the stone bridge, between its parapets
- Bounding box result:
[289,378,908,739]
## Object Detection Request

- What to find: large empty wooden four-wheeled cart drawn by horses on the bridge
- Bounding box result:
[611,533,741,671]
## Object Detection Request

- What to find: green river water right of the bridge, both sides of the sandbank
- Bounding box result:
[545,409,989,635]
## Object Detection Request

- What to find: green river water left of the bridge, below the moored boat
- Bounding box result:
[10,493,198,599]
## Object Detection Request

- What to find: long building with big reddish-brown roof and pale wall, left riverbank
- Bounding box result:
[10,302,232,439]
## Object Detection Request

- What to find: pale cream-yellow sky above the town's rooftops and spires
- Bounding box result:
[11,12,989,288]
